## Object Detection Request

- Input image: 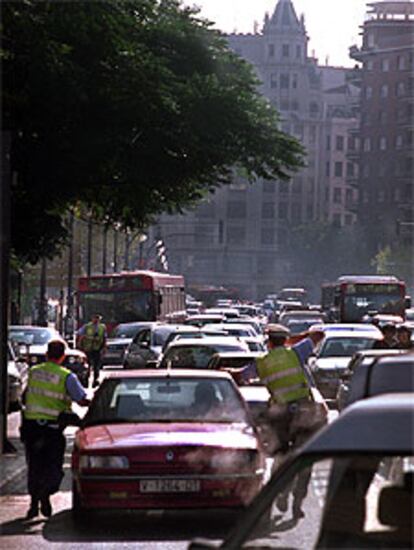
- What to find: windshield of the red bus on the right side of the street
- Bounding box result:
[344,285,404,322]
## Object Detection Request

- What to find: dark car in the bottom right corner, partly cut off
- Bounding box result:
[190,394,414,550]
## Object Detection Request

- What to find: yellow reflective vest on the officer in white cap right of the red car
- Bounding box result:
[256,347,311,404]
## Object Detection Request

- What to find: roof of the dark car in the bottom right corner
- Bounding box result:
[302,393,414,454]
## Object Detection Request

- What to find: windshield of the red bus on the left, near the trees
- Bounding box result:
[79,290,156,323]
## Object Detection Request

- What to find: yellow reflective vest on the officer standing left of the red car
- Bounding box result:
[24,362,72,420]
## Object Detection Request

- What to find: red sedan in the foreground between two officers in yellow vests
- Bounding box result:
[72,369,265,518]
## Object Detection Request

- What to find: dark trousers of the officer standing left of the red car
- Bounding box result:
[22,420,66,499]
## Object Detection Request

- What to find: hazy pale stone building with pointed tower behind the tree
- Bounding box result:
[153,0,357,299]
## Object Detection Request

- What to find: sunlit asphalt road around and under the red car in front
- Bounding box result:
[0,382,336,550]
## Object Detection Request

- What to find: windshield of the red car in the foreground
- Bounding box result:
[85,377,248,425]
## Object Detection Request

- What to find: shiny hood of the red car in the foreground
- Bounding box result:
[77,422,257,451]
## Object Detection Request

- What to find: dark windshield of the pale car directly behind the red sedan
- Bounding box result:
[162,344,243,369]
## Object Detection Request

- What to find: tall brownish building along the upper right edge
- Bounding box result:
[351,1,414,252]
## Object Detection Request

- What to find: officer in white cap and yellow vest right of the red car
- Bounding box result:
[239,324,328,519]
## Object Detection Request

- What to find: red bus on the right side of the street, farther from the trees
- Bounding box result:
[322,275,406,323]
